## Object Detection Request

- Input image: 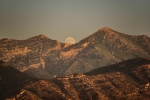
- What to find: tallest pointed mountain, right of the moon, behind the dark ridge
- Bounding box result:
[63,27,150,73]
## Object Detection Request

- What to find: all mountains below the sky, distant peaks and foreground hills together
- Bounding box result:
[0,27,150,100]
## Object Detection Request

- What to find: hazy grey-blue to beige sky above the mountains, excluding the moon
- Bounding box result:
[0,0,150,42]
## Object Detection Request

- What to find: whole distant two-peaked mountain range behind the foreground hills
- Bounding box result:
[0,27,150,79]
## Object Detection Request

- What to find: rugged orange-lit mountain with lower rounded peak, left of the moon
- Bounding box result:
[0,35,65,78]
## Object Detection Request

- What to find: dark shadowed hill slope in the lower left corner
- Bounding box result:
[0,60,37,100]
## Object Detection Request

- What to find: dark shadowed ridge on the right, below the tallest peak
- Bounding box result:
[85,58,150,75]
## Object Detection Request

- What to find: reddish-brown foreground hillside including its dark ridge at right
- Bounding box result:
[3,58,150,100]
